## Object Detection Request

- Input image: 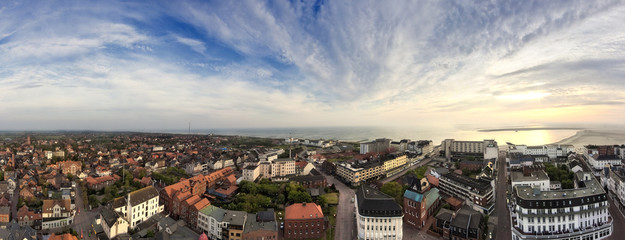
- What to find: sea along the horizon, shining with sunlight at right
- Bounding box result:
[166,127,577,145]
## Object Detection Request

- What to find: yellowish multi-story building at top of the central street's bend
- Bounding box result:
[335,160,384,186]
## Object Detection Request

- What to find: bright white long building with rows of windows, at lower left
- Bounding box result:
[112,186,164,228]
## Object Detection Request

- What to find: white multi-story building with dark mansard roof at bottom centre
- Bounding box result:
[355,185,403,240]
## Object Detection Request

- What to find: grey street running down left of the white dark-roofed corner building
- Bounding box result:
[319,171,356,240]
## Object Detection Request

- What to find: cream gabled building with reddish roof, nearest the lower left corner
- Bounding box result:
[41,199,74,229]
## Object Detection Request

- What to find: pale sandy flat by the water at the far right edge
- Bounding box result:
[555,130,625,147]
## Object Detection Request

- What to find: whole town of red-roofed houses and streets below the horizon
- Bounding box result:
[0,132,625,240]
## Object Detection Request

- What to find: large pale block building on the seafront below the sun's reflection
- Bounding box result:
[441,139,499,160]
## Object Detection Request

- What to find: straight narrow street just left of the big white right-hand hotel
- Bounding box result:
[491,152,512,240]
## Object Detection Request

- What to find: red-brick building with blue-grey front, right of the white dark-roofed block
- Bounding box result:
[404,178,440,229]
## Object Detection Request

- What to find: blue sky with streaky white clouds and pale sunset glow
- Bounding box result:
[0,0,625,130]
